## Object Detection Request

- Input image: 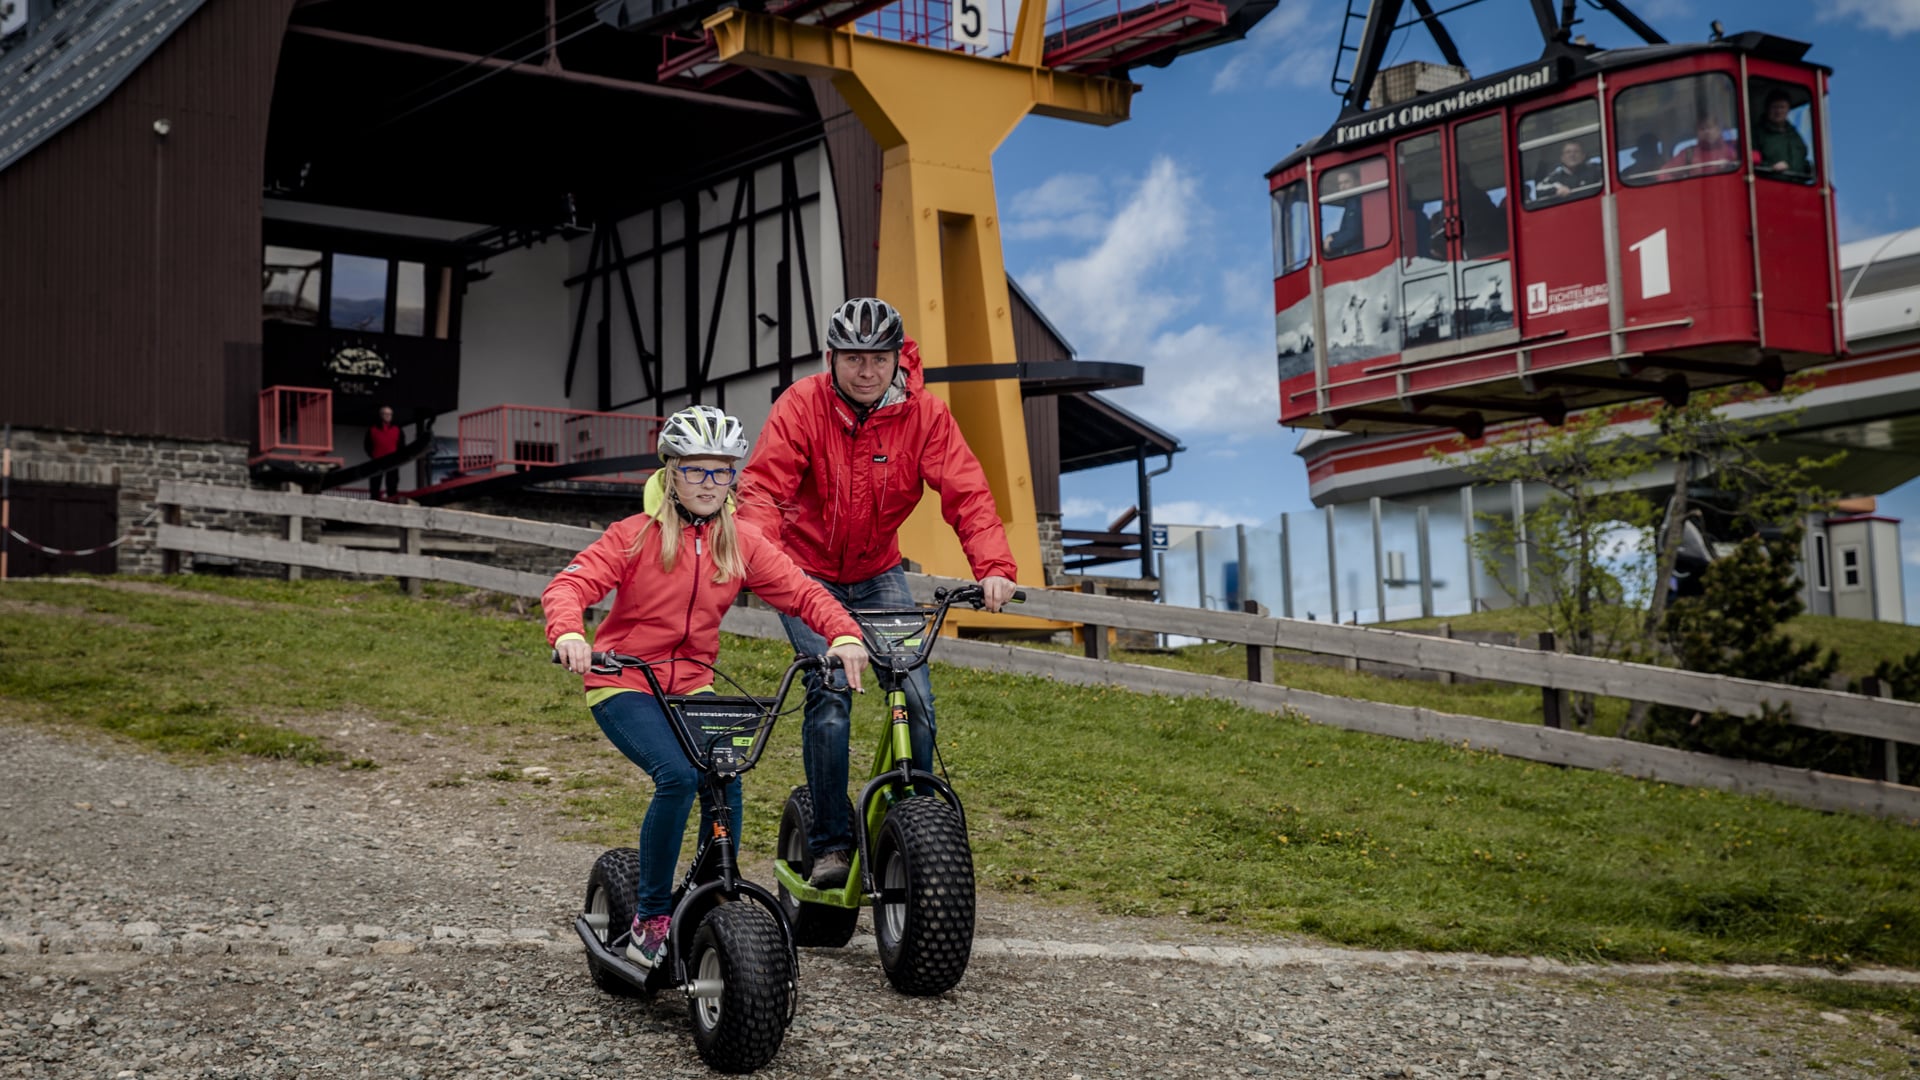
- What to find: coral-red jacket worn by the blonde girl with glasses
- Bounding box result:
[540,471,860,694]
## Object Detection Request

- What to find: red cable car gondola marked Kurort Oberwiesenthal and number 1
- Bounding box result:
[1267,0,1845,436]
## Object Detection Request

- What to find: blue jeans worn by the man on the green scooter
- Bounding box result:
[780,567,933,859]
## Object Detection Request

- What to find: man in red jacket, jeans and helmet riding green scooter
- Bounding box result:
[739,298,1018,888]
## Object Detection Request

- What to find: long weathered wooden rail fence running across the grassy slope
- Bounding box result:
[156,482,1920,821]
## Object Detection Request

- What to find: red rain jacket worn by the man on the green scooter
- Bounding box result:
[739,338,1018,584]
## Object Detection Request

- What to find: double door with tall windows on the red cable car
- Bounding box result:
[1396,113,1513,359]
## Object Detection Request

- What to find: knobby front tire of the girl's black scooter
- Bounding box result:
[687,901,795,1072]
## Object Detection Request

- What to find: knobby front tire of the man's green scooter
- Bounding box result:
[874,796,973,995]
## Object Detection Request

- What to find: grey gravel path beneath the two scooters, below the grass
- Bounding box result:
[0,719,1920,1080]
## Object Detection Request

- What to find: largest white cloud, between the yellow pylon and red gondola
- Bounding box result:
[1021,158,1279,436]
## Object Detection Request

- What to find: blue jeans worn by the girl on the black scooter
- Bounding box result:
[593,694,743,914]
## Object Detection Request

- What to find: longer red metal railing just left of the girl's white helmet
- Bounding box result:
[459,405,662,484]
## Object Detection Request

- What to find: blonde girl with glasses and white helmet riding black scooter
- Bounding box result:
[540,405,866,967]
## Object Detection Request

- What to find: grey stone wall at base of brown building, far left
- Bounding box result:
[12,429,248,575]
